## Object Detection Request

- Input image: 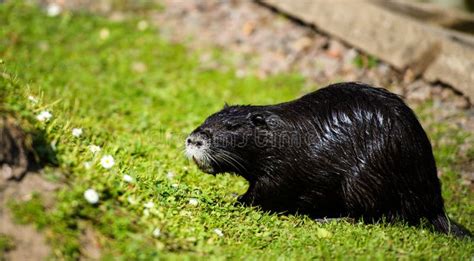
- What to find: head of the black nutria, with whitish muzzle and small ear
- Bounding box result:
[185,106,282,176]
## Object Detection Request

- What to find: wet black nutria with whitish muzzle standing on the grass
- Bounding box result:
[186,83,470,237]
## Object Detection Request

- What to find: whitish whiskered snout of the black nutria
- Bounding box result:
[185,130,214,174]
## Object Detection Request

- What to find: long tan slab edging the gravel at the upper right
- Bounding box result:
[264,0,474,100]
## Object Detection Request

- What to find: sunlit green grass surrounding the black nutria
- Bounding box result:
[0,2,474,260]
